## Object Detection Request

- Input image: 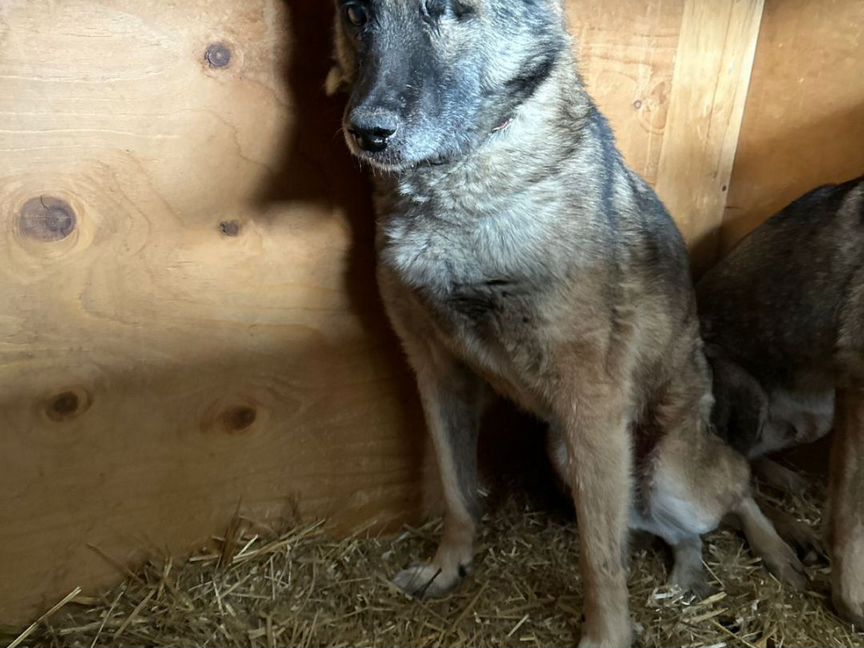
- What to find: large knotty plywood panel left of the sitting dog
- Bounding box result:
[0,0,422,623]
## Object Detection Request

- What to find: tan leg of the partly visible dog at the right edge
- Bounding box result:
[829,388,864,628]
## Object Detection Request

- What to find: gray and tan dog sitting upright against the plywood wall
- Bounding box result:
[328,0,802,647]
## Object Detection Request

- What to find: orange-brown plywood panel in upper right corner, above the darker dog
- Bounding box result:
[721,0,864,250]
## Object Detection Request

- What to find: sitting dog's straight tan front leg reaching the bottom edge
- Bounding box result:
[562,389,632,648]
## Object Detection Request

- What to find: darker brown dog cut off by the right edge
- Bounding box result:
[697,177,864,627]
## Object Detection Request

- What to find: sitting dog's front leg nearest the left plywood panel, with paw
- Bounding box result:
[394,349,487,597]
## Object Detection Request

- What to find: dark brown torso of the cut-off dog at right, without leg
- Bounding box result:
[697,178,864,385]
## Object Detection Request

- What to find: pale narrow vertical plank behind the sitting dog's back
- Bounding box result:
[656,0,763,268]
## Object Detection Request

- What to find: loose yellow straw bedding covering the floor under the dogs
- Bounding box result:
[13,470,864,648]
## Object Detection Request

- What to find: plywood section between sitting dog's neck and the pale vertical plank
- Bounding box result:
[567,0,684,184]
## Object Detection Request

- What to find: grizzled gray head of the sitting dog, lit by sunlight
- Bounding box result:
[327,0,569,170]
